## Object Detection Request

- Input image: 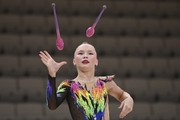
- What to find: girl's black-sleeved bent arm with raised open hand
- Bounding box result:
[39,51,67,110]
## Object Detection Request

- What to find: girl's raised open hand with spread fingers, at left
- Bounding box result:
[39,51,67,77]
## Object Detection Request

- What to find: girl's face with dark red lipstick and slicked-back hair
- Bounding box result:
[73,43,98,71]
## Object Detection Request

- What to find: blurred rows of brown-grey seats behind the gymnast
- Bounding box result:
[0,0,180,120]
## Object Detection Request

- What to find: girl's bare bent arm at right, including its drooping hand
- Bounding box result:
[106,80,134,118]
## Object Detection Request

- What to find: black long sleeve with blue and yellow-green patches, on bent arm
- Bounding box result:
[46,75,68,110]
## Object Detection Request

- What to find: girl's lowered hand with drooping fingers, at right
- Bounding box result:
[119,98,134,119]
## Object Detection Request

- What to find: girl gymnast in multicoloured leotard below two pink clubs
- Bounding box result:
[39,42,134,120]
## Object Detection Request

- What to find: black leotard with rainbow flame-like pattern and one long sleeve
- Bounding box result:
[46,76,114,120]
